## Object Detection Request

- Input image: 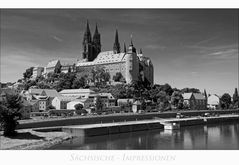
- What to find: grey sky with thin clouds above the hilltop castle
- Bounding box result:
[0,9,239,95]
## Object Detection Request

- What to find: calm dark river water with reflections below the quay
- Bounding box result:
[49,122,239,150]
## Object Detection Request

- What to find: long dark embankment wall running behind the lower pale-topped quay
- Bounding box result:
[17,109,239,129]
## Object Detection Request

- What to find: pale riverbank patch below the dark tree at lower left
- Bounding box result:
[0,129,72,150]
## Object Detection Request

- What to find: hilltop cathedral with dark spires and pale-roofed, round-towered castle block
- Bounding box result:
[76,21,154,85]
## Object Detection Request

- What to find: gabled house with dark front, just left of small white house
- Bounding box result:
[183,93,207,110]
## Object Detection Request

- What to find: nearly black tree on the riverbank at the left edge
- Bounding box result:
[0,95,22,136]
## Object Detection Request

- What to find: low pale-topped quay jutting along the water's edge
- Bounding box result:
[62,114,239,137]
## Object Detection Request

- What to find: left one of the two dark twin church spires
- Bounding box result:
[82,20,93,61]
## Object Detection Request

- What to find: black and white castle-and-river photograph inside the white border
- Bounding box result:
[0,0,239,163]
